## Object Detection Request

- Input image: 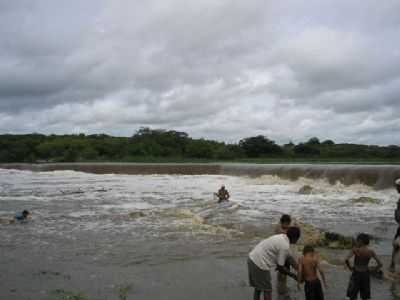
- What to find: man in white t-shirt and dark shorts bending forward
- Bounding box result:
[247,226,300,300]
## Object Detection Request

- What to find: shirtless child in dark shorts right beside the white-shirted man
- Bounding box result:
[297,245,327,300]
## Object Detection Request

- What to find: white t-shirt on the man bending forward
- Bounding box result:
[249,234,290,270]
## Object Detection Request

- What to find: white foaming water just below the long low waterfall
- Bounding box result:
[0,170,398,244]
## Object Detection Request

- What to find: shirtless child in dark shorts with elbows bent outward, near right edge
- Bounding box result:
[345,233,382,300]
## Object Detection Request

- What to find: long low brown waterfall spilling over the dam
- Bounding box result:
[0,163,400,189]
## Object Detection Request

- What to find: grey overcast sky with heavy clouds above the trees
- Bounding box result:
[0,0,400,145]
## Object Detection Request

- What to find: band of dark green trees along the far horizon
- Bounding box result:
[0,128,400,163]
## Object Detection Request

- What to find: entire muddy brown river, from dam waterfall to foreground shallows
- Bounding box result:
[0,164,400,300]
